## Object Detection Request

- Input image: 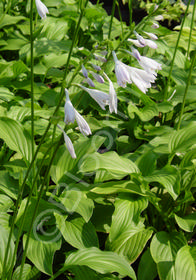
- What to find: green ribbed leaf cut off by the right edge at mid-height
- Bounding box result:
[168,122,196,154]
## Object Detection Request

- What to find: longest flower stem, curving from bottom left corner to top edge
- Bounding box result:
[2,0,88,279]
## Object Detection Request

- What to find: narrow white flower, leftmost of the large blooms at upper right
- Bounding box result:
[112,51,131,88]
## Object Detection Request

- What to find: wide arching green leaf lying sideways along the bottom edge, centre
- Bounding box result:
[65,247,136,280]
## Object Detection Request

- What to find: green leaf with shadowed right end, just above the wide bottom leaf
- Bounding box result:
[55,214,99,249]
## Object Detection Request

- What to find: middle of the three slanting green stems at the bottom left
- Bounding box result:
[7,143,57,280]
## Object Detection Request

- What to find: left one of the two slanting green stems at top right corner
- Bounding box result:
[164,0,191,101]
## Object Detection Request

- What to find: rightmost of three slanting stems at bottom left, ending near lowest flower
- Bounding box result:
[18,138,61,280]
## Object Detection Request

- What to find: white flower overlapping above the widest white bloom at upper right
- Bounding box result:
[127,47,162,76]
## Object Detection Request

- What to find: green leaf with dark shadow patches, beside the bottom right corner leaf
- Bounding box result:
[150,231,186,280]
